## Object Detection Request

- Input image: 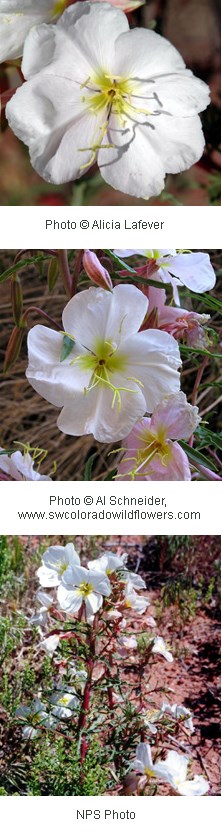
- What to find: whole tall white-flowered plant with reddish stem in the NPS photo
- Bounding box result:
[11,542,209,796]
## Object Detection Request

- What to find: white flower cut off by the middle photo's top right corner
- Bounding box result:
[114,249,216,305]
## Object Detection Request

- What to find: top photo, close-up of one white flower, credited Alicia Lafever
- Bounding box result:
[0,0,221,206]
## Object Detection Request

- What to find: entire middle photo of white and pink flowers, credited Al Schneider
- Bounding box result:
[0,248,222,481]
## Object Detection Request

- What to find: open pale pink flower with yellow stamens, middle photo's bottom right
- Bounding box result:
[117,392,199,482]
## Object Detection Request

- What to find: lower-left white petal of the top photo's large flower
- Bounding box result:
[6,74,106,184]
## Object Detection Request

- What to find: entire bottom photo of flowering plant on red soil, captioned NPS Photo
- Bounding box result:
[0,535,221,797]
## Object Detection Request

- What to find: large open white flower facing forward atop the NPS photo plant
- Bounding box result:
[57,566,111,618]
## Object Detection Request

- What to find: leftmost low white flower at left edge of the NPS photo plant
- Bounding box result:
[15,698,56,739]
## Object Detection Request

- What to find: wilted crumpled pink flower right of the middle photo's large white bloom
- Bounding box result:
[142,287,210,349]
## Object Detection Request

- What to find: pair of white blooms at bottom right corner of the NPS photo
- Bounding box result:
[132,744,209,796]
